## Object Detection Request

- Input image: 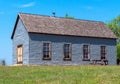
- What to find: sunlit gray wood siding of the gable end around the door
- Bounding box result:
[12,19,29,64]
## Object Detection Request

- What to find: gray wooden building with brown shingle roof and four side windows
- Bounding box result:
[11,13,116,65]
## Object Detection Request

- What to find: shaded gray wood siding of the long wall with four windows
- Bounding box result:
[29,33,116,65]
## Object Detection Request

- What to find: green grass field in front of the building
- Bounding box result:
[0,66,120,84]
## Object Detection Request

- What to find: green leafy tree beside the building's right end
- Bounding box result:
[107,15,120,43]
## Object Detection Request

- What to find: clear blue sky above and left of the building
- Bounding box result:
[0,0,120,65]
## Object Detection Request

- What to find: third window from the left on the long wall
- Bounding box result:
[83,45,90,61]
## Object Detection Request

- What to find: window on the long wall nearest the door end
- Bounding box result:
[43,42,51,60]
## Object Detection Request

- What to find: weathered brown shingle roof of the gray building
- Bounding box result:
[13,13,116,38]
